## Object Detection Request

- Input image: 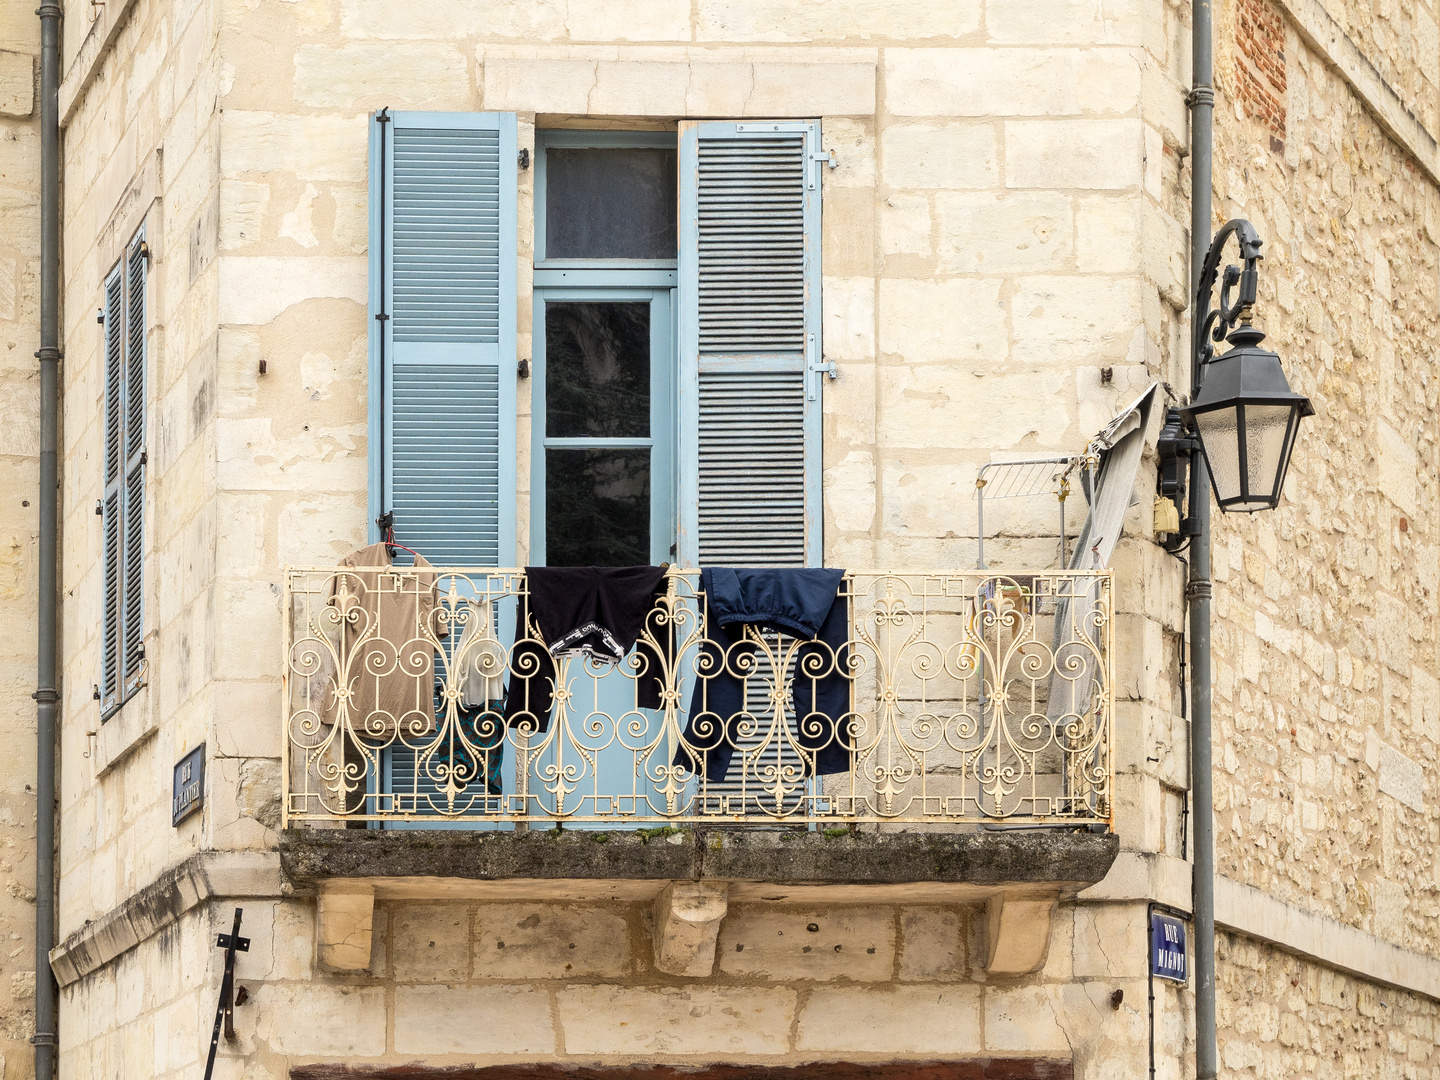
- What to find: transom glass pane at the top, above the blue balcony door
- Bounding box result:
[544,147,677,259]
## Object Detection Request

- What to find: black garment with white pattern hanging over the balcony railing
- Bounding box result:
[505,566,668,732]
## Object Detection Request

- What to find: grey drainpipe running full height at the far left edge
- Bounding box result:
[32,0,60,1080]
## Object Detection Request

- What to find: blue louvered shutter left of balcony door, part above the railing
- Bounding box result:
[370,112,517,566]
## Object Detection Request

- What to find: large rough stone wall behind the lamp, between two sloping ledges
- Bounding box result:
[1214,4,1440,955]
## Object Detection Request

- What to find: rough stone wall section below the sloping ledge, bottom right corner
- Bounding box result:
[1215,933,1440,1080]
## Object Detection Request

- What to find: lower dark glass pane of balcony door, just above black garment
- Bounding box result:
[544,448,649,566]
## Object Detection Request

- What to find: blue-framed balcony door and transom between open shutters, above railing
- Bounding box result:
[530,131,678,566]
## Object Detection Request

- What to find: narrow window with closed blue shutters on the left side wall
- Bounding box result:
[101,229,150,720]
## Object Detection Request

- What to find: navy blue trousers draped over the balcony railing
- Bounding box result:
[675,566,850,780]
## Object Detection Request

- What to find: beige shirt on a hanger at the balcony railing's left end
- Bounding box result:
[320,543,448,743]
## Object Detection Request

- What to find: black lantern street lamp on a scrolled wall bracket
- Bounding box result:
[1158,217,1315,535]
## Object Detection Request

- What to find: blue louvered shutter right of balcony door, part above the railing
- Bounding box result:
[678,121,824,566]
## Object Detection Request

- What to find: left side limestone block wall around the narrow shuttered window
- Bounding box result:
[59,0,223,936]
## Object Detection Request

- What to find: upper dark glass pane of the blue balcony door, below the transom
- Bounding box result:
[544,301,649,439]
